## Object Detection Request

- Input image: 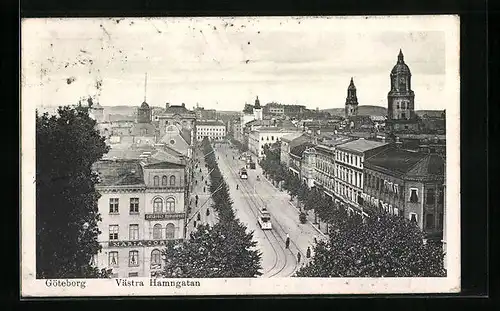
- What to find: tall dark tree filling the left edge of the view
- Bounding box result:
[36,106,109,278]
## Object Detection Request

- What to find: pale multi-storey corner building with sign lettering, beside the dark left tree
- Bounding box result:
[94,159,186,278]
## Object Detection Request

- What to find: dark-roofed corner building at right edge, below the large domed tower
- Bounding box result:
[363,147,445,240]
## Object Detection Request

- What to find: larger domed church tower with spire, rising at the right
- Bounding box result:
[387,50,418,131]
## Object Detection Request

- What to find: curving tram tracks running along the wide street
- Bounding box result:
[217,147,300,277]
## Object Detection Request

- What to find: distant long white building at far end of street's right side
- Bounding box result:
[248,127,299,158]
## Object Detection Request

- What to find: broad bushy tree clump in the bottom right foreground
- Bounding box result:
[296,214,446,277]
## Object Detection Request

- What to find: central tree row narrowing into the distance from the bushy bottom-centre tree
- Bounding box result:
[163,138,262,278]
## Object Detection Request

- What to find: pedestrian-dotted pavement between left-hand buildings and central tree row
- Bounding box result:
[186,150,217,238]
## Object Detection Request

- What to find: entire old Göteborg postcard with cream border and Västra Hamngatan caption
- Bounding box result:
[20,15,460,297]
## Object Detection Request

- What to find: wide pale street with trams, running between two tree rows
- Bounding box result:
[212,145,321,277]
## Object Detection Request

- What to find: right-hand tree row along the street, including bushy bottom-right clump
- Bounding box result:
[261,143,446,277]
